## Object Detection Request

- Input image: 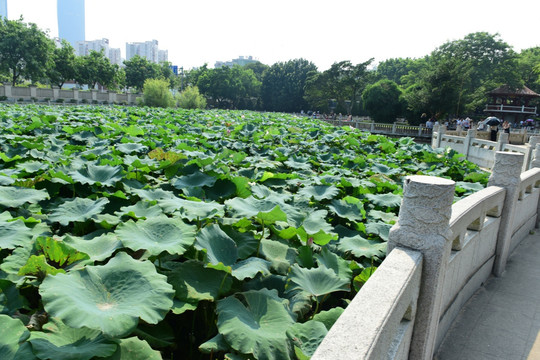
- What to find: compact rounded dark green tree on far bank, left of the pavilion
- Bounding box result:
[362,79,403,123]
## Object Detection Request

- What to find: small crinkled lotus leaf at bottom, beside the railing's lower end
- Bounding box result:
[287,320,328,358]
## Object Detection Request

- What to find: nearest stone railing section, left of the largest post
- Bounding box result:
[311,247,422,360]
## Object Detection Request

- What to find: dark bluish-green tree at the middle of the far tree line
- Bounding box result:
[261,59,317,112]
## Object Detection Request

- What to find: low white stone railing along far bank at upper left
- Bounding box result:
[0,84,142,105]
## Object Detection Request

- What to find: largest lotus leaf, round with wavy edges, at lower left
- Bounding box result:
[39,252,174,337]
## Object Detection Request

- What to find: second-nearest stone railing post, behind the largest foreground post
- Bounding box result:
[488,152,524,276]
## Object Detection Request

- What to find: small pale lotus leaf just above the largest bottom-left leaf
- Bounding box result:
[63,233,122,261]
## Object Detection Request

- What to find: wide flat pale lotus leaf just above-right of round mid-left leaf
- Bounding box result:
[158,198,224,221]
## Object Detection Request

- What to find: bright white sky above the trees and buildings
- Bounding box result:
[8,0,540,71]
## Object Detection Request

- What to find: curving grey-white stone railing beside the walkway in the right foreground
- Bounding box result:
[312,151,540,360]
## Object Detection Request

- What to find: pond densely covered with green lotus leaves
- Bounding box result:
[0,105,487,360]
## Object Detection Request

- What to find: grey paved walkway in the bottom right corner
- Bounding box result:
[434,230,540,360]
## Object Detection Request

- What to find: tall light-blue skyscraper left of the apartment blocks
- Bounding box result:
[57,0,85,47]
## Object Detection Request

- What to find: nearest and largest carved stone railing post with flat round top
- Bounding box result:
[388,176,455,360]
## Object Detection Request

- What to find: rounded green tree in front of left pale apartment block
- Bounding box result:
[75,50,118,89]
